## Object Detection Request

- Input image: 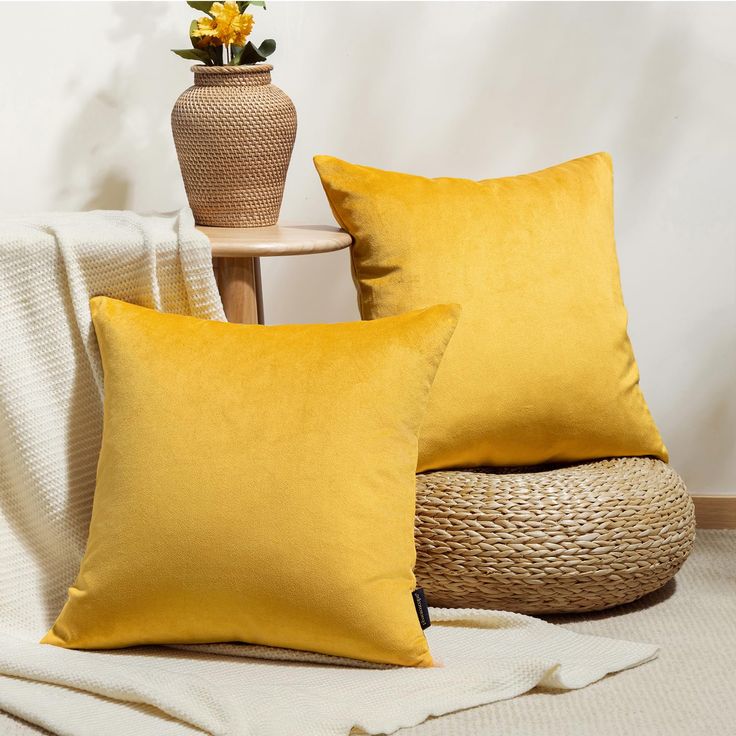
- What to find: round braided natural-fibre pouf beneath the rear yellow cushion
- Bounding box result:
[416,458,695,613]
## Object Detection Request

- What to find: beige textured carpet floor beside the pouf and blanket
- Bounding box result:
[0,531,736,736]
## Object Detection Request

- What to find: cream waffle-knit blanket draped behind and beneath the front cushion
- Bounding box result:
[0,212,656,736]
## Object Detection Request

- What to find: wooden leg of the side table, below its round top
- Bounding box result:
[212,258,263,324]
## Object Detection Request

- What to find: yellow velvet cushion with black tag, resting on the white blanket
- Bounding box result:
[43,297,459,667]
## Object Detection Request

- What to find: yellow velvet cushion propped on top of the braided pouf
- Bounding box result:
[315,153,667,470]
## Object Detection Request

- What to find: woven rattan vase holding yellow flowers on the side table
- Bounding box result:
[171,64,296,227]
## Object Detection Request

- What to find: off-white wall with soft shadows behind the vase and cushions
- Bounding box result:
[0,2,736,493]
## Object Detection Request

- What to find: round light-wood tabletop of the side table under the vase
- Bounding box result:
[197,225,353,258]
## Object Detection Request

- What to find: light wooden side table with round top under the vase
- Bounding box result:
[197,225,352,324]
